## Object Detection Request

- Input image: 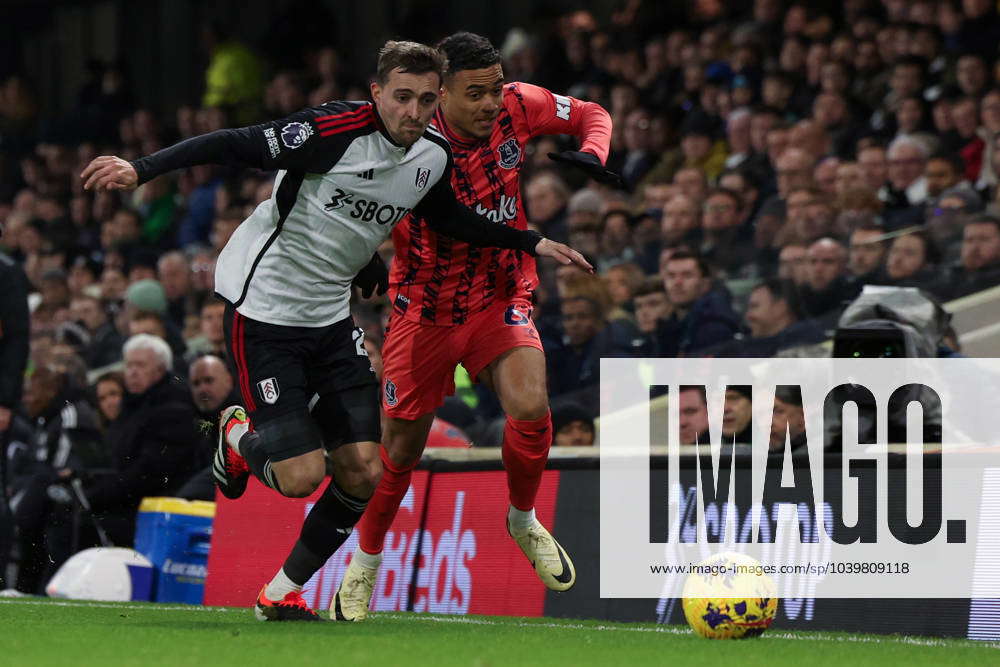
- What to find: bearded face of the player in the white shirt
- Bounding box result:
[371,67,441,147]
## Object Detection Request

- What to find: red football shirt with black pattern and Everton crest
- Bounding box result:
[389,83,611,325]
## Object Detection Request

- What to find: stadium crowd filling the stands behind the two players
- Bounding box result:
[0,0,1000,591]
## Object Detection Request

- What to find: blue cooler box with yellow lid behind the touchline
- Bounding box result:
[135,498,215,604]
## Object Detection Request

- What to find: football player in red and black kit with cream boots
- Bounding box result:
[330,32,617,621]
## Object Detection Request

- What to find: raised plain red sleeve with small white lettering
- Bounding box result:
[509,82,611,164]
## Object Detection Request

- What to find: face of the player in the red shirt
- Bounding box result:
[441,64,503,139]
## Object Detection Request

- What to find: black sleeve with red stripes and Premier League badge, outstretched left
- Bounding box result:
[132,102,374,184]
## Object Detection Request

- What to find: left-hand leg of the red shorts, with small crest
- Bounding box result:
[382,316,459,421]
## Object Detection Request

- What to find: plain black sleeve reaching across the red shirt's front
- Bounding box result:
[413,162,542,255]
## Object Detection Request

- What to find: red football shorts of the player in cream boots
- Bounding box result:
[382,300,542,419]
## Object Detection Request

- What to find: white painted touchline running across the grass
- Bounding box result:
[0,598,1000,649]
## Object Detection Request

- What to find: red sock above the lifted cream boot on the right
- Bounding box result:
[503,412,552,512]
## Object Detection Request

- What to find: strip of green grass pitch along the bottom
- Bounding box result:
[0,598,1000,667]
